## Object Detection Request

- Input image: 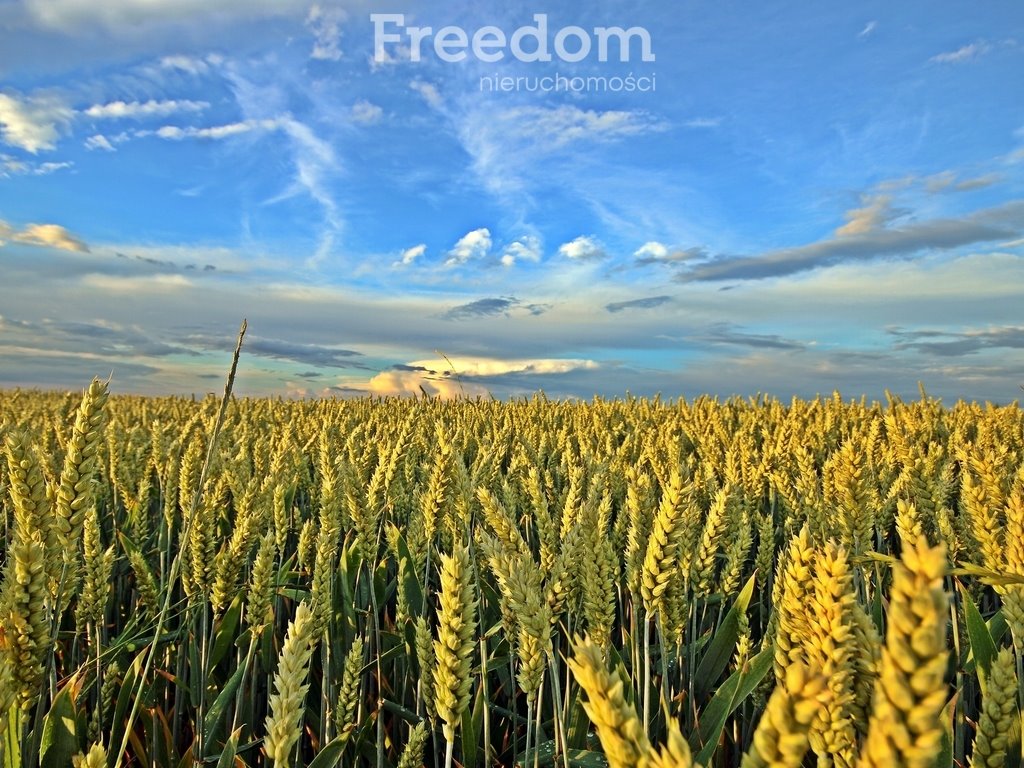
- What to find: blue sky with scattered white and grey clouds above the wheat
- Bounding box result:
[0,0,1024,401]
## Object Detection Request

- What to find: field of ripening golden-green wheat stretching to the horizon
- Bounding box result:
[0,366,1024,768]
